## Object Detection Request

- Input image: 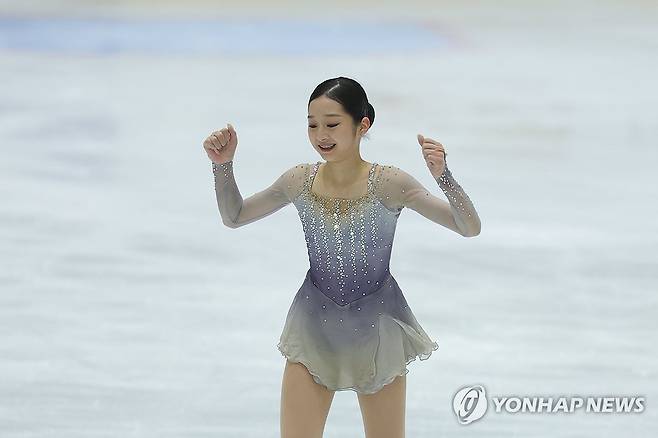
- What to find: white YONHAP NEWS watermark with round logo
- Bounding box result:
[452,385,646,424]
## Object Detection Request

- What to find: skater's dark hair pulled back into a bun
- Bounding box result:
[308,76,375,139]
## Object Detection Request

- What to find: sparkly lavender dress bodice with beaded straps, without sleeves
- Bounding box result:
[293,162,400,306]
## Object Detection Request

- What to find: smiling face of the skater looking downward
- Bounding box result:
[308,96,370,161]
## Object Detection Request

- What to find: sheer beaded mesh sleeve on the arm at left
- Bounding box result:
[212,160,310,228]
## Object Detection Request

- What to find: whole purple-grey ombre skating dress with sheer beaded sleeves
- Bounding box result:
[213,161,479,394]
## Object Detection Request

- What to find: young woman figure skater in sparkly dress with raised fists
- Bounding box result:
[203,77,480,438]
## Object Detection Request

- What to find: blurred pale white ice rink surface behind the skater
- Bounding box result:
[0,0,658,438]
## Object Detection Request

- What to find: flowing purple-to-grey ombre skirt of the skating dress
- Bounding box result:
[277,269,439,394]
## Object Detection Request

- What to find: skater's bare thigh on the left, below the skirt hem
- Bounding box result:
[281,360,335,438]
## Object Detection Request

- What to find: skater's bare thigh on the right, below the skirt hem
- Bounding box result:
[357,375,407,438]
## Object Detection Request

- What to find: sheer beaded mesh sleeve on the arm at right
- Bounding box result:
[376,164,480,237]
